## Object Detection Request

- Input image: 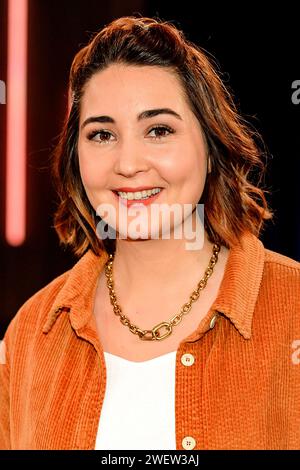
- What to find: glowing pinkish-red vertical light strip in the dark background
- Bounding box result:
[5,0,28,246]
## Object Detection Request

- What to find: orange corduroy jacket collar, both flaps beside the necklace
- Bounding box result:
[43,232,265,339]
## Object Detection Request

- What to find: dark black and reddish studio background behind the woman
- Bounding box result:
[0,0,300,339]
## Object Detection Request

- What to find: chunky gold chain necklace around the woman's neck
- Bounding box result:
[105,243,221,341]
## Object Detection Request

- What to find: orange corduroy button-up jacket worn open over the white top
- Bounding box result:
[0,230,300,450]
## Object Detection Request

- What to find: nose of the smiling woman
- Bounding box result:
[114,139,149,177]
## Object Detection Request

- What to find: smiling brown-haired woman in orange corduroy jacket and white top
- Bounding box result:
[0,13,300,450]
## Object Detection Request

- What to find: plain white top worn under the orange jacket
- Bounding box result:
[95,351,176,450]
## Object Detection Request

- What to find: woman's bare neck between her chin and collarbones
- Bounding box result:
[113,213,218,298]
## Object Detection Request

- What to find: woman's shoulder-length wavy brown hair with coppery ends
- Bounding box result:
[52,16,274,256]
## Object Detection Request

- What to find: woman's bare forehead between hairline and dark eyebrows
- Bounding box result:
[81,64,187,114]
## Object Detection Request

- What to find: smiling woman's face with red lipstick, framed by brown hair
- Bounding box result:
[78,64,206,238]
